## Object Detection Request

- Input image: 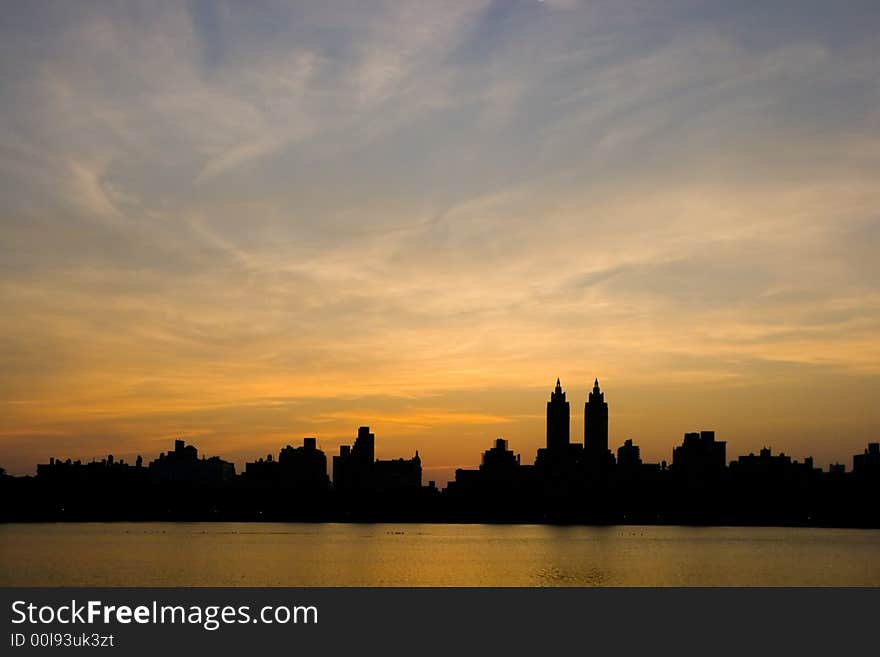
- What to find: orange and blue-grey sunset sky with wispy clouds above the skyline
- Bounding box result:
[0,0,880,482]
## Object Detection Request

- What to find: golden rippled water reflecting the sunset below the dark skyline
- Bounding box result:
[0,523,880,586]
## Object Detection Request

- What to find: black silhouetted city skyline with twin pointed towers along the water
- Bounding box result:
[0,379,880,527]
